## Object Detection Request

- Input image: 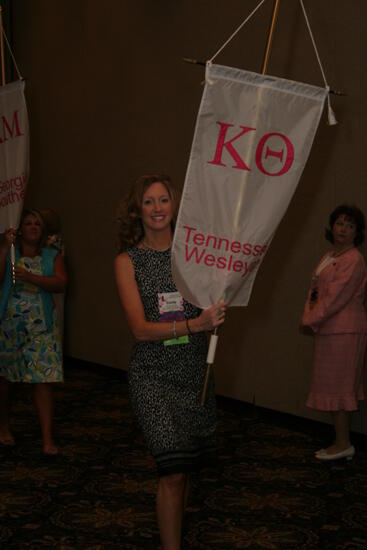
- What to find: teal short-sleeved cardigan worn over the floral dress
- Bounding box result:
[0,248,58,330]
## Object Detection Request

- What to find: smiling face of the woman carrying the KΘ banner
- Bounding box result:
[141,182,173,232]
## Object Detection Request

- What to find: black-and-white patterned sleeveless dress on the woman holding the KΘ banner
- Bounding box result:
[126,247,217,476]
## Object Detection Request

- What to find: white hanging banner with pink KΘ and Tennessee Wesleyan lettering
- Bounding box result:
[172,65,327,308]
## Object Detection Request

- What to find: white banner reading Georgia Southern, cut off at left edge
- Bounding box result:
[0,80,29,233]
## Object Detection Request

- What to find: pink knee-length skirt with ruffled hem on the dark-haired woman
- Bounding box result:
[306,334,367,411]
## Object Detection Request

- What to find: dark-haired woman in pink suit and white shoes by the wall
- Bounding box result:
[302,205,367,460]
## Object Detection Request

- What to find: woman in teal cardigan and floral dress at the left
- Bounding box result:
[0,210,67,455]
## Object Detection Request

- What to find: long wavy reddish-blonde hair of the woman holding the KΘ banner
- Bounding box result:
[116,174,179,253]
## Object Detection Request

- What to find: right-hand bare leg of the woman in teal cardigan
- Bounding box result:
[34,383,58,455]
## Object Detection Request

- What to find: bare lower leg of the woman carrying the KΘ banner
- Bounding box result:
[157,474,186,550]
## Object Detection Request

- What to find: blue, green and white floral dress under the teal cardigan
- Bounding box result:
[0,256,63,383]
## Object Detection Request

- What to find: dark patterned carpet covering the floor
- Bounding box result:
[0,361,367,550]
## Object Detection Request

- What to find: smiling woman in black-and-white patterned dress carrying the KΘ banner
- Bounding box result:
[115,175,226,550]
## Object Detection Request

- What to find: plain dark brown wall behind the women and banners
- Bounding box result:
[8,0,367,433]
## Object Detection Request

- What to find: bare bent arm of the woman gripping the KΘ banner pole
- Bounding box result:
[115,253,226,341]
